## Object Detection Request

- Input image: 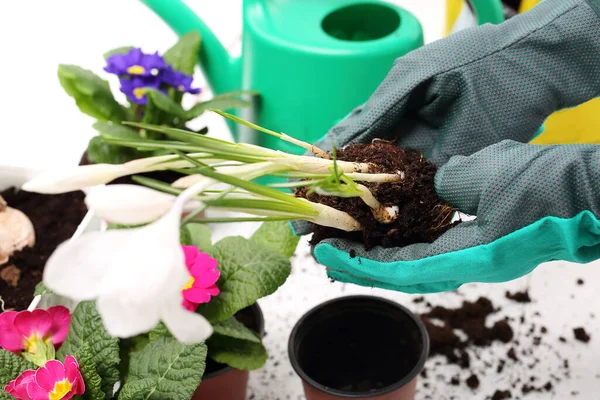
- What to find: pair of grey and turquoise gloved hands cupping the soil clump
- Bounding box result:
[295,0,600,293]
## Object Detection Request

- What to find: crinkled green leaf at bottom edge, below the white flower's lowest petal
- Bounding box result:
[119,338,206,400]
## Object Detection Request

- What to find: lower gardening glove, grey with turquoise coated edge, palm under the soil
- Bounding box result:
[314,140,600,293]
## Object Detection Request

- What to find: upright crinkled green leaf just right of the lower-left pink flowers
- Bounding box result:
[57,301,120,398]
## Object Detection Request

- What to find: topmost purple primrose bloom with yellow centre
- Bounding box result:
[104,48,167,77]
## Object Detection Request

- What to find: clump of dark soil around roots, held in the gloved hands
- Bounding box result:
[296,141,454,250]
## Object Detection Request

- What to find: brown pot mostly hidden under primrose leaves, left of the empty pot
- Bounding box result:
[191,303,265,400]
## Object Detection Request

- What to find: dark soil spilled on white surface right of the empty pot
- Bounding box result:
[415,291,600,400]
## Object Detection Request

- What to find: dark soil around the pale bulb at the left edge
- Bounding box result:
[0,188,87,310]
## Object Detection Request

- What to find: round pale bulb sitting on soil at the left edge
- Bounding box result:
[0,196,35,264]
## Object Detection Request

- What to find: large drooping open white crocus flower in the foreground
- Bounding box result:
[44,179,214,344]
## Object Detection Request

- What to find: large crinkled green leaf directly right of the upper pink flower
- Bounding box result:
[197,236,291,323]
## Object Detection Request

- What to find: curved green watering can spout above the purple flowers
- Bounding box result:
[142,0,242,94]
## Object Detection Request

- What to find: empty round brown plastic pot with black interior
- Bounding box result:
[288,296,429,400]
